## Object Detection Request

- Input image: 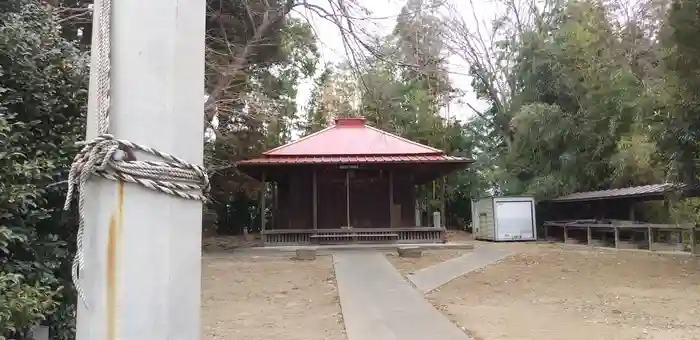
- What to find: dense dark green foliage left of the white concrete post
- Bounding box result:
[0,0,88,339]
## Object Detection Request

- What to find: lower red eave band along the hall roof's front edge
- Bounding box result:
[237,155,473,166]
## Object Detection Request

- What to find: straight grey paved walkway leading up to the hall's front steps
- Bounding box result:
[333,251,469,340]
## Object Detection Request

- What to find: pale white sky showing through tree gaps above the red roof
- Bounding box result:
[294,0,498,121]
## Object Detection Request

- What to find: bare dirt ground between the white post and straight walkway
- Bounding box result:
[202,254,347,340]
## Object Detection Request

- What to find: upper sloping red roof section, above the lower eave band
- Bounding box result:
[263,117,444,157]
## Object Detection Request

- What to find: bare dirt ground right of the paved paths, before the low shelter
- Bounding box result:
[428,244,700,340]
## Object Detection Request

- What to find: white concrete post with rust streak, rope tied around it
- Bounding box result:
[77,0,205,340]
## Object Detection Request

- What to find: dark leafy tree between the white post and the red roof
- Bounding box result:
[206,17,318,233]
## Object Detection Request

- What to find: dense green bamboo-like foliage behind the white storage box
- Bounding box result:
[464,0,665,199]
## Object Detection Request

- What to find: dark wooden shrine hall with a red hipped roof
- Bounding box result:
[237,117,472,244]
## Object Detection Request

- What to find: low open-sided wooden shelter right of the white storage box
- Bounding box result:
[538,183,699,254]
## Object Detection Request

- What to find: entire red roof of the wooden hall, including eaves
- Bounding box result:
[238,117,471,165]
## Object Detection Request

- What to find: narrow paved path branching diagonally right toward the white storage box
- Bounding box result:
[406,247,512,293]
